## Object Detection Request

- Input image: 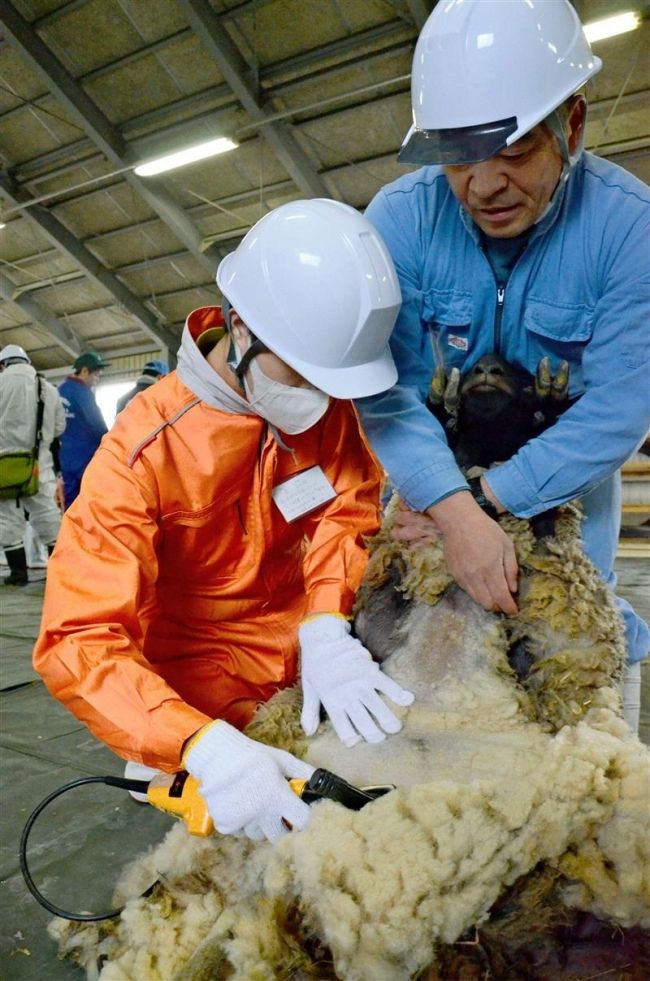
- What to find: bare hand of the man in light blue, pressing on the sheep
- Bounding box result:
[427,491,518,616]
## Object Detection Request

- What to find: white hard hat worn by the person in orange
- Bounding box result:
[217,198,402,398]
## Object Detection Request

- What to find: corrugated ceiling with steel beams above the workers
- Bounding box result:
[0,0,650,371]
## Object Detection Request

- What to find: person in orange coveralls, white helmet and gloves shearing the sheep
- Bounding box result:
[34,200,412,840]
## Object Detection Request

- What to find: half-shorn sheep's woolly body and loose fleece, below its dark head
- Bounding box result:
[50,508,650,981]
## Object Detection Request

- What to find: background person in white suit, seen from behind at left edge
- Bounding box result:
[0,344,65,586]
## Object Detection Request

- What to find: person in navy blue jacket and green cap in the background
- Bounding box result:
[59,351,110,509]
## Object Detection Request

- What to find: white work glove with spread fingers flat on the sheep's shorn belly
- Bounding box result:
[298,613,415,746]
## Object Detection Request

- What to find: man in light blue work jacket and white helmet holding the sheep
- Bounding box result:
[359,0,650,725]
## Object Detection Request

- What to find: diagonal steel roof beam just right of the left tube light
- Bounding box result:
[178,0,330,198]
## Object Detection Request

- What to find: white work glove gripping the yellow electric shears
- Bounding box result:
[183,720,314,841]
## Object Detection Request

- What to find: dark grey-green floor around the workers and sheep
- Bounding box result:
[0,558,650,981]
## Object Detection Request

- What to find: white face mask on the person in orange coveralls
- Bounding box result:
[236,345,329,436]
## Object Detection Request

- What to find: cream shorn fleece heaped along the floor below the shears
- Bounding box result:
[52,710,650,981]
